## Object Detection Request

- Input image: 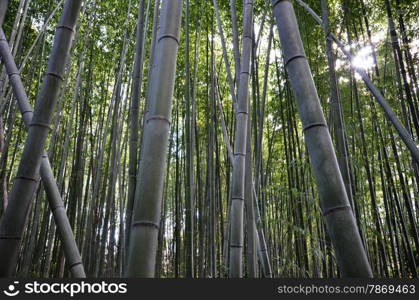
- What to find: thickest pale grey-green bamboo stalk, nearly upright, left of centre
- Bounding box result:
[127,0,182,277]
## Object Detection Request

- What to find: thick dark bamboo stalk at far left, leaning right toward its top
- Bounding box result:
[0,0,82,276]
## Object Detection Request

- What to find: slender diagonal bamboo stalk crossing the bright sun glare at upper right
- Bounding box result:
[296,0,419,164]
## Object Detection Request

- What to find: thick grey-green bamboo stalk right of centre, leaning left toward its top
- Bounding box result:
[272,0,372,277]
